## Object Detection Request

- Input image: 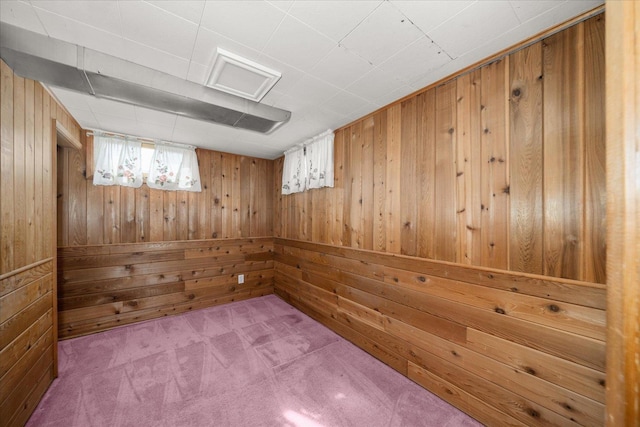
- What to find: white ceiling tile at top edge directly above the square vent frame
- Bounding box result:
[201,0,285,50]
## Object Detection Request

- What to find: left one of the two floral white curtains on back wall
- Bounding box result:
[93,134,142,188]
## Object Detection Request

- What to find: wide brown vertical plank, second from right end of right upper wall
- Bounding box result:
[542,24,584,279]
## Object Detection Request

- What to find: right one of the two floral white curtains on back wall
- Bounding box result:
[147,143,202,192]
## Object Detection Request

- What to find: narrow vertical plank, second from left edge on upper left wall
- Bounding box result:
[13,74,27,268]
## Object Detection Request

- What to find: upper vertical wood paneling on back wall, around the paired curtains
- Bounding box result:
[58,142,274,246]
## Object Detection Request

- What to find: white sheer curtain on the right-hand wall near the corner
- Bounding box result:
[282,130,334,194]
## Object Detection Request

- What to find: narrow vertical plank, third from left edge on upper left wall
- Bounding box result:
[23,80,38,265]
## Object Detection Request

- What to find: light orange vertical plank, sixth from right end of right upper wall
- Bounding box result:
[433,81,457,262]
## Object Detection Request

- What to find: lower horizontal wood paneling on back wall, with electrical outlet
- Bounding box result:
[58,238,274,338]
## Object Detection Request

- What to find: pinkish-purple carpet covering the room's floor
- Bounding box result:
[27,295,480,427]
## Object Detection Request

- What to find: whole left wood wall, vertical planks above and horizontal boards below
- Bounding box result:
[0,57,80,426]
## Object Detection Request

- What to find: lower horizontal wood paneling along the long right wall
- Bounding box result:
[274,238,606,426]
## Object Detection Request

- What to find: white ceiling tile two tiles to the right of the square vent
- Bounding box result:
[310,46,373,87]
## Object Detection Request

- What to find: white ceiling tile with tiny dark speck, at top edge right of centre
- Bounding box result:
[428,1,519,57]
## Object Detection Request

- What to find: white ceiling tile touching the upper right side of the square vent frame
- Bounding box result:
[263,17,336,71]
